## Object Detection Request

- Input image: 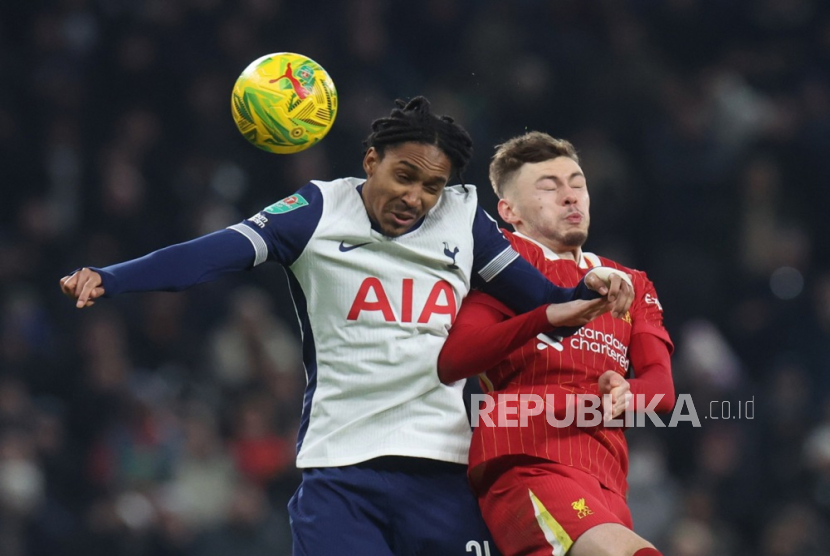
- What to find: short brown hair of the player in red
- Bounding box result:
[490,131,579,199]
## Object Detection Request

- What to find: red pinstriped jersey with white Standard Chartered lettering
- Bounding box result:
[442,232,674,495]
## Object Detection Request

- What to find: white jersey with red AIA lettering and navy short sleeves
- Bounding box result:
[231,178,518,468]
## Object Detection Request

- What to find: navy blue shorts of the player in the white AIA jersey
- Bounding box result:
[288,457,498,556]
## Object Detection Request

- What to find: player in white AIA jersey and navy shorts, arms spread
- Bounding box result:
[61,97,633,556]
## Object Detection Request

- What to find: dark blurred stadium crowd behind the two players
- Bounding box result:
[0,0,830,556]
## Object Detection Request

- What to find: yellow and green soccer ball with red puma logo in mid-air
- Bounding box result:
[231,52,337,154]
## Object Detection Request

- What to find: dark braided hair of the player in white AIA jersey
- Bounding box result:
[363,96,473,183]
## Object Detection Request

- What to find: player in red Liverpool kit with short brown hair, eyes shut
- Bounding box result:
[438,132,674,556]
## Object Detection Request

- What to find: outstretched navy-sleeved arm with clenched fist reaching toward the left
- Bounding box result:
[60,230,255,309]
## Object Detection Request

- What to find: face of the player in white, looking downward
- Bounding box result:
[363,143,452,237]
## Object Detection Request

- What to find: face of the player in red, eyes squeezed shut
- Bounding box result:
[499,156,591,252]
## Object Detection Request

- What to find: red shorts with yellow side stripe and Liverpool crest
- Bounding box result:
[473,456,633,556]
